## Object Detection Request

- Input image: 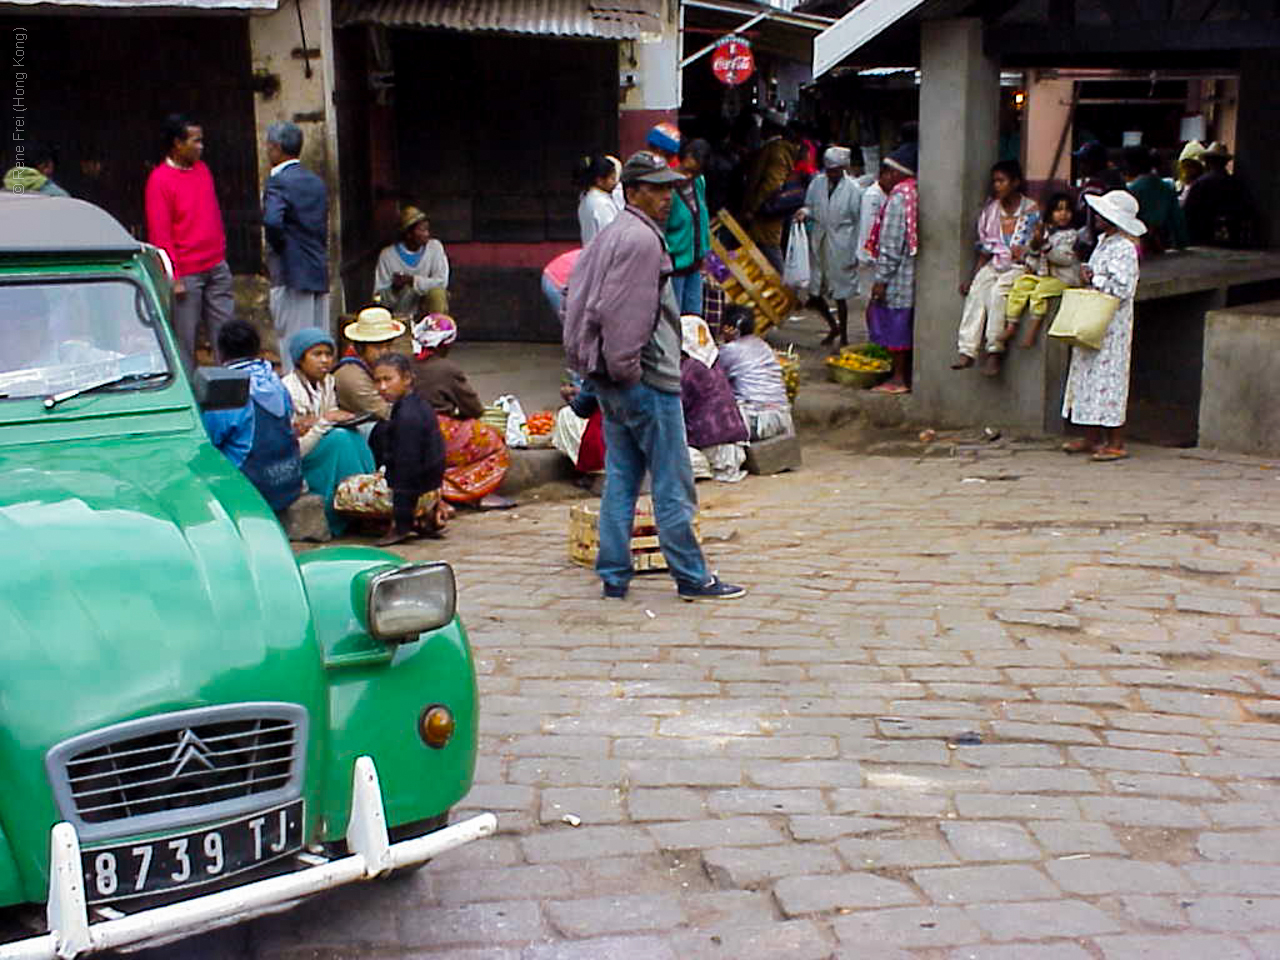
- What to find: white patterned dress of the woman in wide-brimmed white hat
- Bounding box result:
[1062,233,1138,428]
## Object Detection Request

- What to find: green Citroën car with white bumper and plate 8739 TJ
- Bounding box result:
[0,193,495,960]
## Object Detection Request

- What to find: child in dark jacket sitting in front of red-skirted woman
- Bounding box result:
[369,353,444,547]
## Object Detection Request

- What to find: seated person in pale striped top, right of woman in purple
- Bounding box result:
[718,303,795,440]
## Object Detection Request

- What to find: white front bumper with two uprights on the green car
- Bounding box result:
[0,756,498,960]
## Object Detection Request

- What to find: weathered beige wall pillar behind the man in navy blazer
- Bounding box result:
[248,0,343,312]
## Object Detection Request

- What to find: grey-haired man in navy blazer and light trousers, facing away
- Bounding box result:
[262,123,329,372]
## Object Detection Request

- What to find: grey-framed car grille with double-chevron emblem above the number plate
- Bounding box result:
[49,704,306,836]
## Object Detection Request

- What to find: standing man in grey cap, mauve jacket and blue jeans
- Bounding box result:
[564,151,746,600]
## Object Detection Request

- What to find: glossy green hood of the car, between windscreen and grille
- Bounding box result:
[0,431,325,818]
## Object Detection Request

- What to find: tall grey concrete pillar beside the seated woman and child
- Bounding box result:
[914,18,1000,424]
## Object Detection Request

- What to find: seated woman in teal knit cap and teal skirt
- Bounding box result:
[284,326,374,536]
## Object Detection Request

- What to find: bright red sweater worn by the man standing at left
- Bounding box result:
[146,160,227,276]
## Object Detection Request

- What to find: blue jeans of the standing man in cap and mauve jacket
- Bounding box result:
[595,381,710,586]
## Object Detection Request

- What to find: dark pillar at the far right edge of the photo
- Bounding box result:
[1233,50,1280,247]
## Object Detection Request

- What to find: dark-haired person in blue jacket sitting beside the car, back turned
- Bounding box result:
[201,320,302,512]
